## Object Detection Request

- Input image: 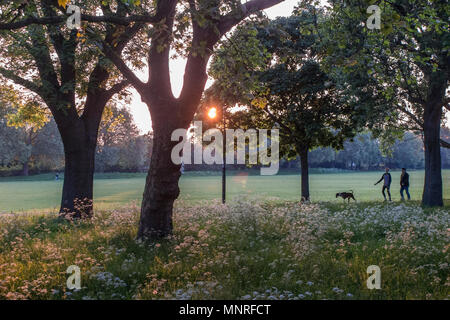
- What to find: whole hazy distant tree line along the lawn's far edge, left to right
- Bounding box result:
[0,100,450,176]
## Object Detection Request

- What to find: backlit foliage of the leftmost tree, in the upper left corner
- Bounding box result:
[0,0,148,118]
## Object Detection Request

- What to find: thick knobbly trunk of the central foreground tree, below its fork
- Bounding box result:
[138,118,181,239]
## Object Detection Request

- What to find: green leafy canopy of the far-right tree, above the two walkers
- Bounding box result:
[320,0,450,132]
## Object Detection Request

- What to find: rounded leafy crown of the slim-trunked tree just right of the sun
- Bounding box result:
[205,8,367,156]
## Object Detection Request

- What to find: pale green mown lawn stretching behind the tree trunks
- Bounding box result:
[0,170,450,213]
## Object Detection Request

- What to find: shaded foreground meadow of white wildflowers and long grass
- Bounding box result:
[0,199,450,300]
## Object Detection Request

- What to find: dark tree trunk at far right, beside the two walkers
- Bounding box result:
[422,105,443,206]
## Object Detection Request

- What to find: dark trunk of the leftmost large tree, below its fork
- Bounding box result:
[60,122,97,218]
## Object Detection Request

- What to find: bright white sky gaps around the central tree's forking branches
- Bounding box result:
[128,0,298,133]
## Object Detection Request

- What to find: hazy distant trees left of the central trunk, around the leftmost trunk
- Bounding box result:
[0,106,151,176]
